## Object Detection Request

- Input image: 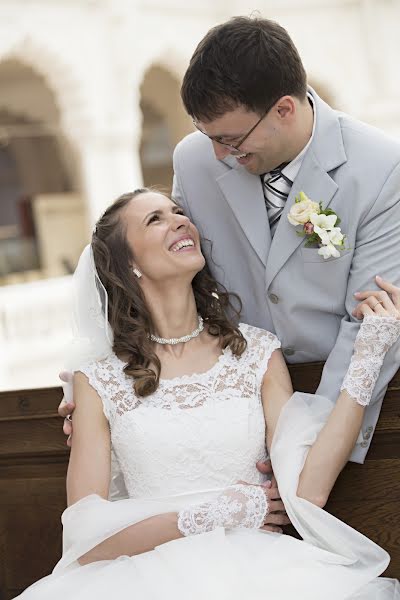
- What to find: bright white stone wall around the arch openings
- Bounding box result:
[0,0,400,388]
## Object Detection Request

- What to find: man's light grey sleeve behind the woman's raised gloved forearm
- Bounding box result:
[317,159,400,462]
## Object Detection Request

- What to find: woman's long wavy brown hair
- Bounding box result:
[92,188,247,397]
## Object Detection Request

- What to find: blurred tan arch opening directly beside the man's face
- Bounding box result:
[140,62,193,189]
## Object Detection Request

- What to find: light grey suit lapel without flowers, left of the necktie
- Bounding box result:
[217,165,271,265]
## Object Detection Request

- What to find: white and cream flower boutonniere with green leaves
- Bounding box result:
[288,192,345,258]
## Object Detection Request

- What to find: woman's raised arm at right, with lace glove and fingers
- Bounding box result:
[263,284,400,507]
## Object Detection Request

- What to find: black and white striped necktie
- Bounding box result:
[262,163,293,237]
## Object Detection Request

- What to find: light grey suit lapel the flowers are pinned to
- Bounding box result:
[266,88,347,287]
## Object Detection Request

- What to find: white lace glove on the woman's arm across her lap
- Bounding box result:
[178,484,268,536]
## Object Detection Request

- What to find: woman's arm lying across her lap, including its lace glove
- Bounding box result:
[67,373,281,565]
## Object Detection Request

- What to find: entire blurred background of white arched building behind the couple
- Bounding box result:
[0,0,400,390]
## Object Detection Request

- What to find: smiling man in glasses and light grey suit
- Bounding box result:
[173,17,400,463]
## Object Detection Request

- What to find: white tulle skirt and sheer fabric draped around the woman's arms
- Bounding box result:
[14,393,400,600]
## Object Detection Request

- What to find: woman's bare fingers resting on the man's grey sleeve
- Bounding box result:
[353,277,400,319]
